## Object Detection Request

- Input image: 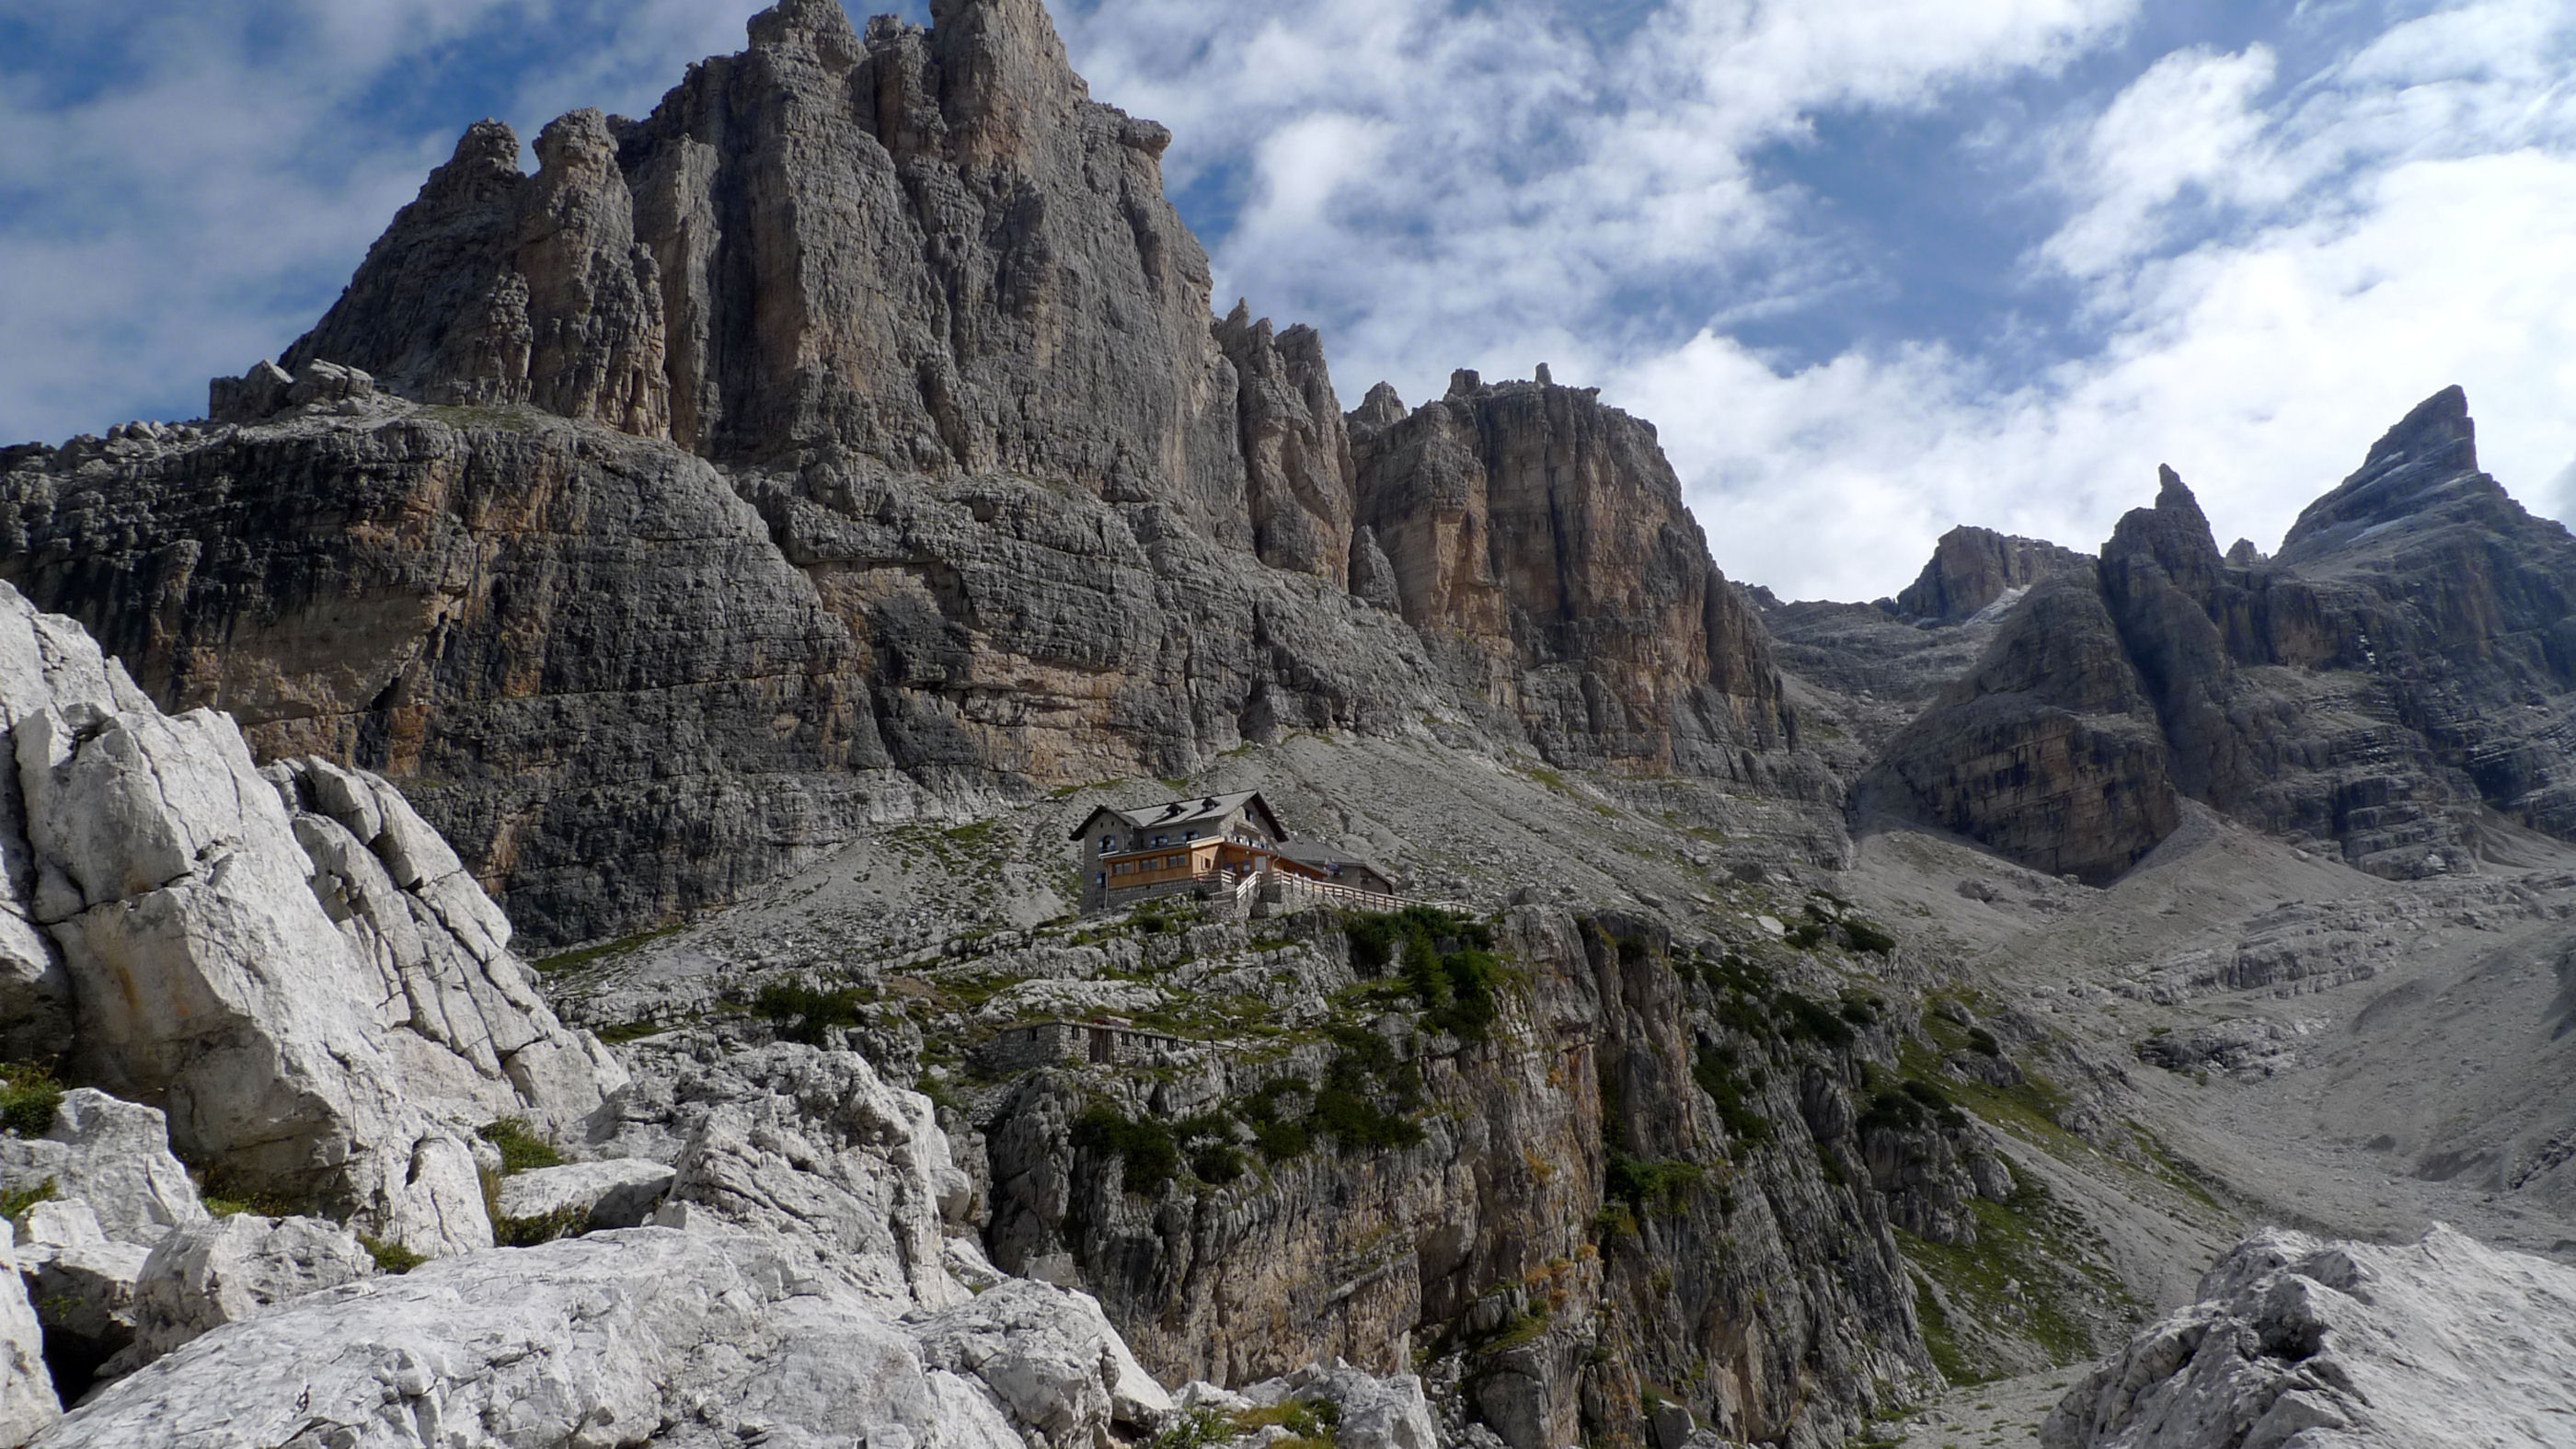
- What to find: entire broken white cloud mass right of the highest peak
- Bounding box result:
[1072,0,2576,598]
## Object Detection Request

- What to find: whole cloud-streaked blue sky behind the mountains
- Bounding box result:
[0,0,2576,598]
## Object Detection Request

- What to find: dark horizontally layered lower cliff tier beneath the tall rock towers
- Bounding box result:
[6,412,1430,938]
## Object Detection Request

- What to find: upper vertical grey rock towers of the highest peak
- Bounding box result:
[286,0,1249,544]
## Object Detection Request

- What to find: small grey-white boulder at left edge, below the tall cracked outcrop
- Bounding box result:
[0,1088,206,1248]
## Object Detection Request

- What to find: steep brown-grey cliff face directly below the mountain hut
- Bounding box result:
[984,907,1947,1449]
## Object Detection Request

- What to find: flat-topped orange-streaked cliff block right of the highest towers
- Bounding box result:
[1352,372,1796,778]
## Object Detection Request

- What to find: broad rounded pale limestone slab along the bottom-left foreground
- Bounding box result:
[41,1227,1025,1449]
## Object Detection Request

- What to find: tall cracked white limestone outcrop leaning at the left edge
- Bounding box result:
[0,577,624,1253]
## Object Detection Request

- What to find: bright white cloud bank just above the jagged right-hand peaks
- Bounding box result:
[1613,3,2576,598]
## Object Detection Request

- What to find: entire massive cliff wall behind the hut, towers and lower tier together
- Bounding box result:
[0,0,1832,941]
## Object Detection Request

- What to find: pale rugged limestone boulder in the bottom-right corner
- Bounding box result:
[2041,1225,2576,1449]
